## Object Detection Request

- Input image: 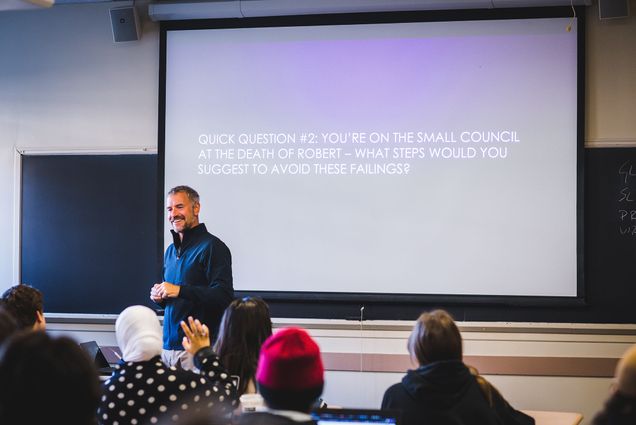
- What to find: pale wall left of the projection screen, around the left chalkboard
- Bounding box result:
[0,2,159,290]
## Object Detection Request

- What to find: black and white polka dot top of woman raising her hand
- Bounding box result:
[97,347,238,425]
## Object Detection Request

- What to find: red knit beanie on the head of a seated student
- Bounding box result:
[256,328,324,390]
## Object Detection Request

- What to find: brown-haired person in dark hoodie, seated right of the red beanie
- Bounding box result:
[382,310,534,425]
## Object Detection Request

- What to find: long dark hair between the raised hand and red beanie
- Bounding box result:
[214,297,272,396]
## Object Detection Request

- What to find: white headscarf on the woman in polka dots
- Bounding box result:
[115,305,163,362]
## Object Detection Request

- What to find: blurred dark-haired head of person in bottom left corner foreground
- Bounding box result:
[0,331,100,425]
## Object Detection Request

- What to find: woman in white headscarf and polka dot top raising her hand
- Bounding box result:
[97,305,237,425]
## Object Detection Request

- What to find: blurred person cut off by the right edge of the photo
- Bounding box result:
[592,345,636,425]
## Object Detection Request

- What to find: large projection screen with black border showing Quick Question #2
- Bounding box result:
[159,9,583,304]
